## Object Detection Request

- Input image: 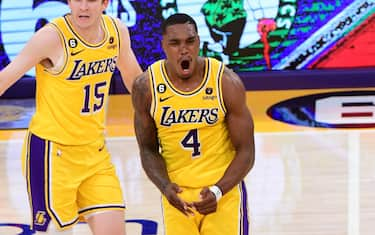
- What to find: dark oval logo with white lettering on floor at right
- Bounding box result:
[267,90,375,128]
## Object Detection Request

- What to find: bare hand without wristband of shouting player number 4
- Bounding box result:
[164,183,194,216]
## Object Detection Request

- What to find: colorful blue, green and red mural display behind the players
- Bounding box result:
[0,0,375,76]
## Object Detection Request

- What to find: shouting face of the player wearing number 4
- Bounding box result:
[162,23,199,79]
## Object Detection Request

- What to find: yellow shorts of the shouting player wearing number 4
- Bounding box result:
[162,182,249,235]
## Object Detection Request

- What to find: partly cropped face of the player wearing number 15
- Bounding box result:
[68,0,108,28]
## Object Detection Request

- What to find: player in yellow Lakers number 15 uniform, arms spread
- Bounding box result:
[0,0,142,235]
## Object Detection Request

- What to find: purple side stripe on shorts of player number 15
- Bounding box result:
[29,135,51,231]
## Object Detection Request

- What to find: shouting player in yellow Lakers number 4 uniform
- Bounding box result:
[132,14,254,235]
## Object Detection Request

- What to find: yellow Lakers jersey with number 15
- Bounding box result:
[29,15,120,145]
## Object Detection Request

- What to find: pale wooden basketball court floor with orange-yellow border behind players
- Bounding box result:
[0,89,375,235]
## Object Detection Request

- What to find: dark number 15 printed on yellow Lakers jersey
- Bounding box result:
[81,81,107,114]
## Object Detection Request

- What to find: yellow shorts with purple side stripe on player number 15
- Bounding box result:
[22,133,125,231]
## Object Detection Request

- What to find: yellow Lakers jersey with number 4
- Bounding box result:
[148,58,235,188]
